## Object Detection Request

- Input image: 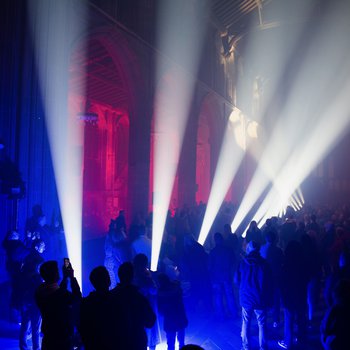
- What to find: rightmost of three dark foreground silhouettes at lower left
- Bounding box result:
[111,262,156,350]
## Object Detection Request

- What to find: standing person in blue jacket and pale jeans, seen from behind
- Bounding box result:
[235,241,273,350]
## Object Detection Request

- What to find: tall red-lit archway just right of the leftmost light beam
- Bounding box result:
[69,37,130,238]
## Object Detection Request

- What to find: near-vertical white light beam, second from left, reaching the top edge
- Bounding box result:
[151,0,207,271]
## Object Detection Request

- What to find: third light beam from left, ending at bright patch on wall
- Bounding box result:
[198,108,247,244]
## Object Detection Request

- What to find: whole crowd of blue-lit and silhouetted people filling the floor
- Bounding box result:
[3,204,350,350]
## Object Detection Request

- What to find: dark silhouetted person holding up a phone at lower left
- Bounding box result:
[35,260,81,350]
